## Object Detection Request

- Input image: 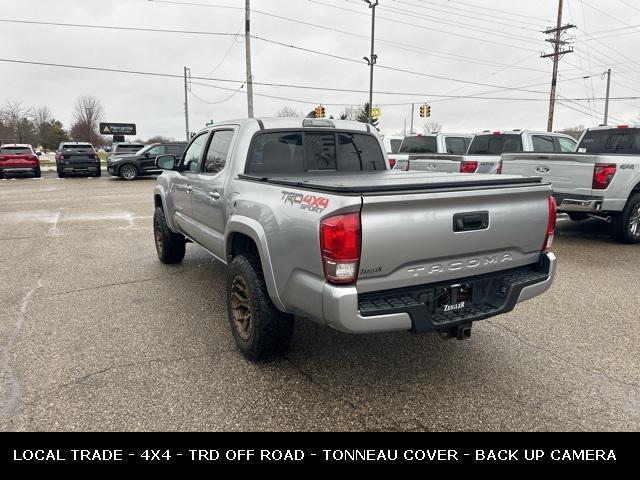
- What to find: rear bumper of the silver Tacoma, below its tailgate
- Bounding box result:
[323,253,556,333]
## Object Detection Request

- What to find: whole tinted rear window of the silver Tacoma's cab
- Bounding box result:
[245,130,386,175]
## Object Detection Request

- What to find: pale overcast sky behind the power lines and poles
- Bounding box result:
[0,0,640,139]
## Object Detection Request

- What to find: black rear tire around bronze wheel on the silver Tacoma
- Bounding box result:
[227,253,294,362]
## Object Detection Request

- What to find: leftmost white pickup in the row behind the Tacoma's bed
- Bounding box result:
[389,133,473,171]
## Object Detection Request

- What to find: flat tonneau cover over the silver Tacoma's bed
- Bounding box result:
[239,170,543,195]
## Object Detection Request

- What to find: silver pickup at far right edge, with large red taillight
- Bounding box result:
[502,125,640,243]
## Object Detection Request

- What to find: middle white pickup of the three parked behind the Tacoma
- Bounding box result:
[396,130,576,173]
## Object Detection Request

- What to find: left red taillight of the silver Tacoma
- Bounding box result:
[320,213,360,284]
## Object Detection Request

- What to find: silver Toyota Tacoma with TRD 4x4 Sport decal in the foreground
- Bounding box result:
[154,118,556,361]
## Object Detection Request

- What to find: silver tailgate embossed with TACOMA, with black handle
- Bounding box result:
[357,174,551,292]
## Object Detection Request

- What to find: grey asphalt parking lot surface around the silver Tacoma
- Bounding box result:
[0,173,640,431]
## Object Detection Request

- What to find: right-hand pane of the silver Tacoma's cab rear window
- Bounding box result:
[338,133,386,172]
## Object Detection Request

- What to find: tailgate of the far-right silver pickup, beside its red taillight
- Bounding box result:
[502,153,596,199]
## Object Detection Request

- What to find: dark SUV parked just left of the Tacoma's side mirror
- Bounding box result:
[107,142,187,180]
